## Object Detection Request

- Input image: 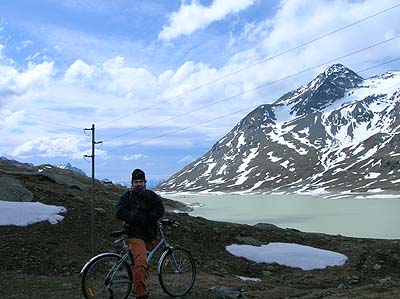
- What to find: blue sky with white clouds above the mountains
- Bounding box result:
[0,0,400,182]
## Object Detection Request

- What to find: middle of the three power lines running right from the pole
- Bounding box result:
[104,35,400,142]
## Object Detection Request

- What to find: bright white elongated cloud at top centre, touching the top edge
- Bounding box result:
[158,0,255,41]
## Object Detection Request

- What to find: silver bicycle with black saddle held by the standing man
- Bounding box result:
[81,219,196,299]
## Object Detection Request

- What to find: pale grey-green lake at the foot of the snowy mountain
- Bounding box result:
[165,194,400,239]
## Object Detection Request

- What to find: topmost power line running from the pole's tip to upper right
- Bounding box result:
[97,4,400,128]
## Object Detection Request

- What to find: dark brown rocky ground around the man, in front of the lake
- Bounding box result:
[0,163,400,299]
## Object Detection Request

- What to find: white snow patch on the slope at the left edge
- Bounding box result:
[0,201,67,226]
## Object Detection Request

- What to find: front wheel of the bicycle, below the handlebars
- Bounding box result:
[158,248,196,297]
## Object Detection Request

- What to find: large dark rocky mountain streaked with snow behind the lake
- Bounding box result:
[158,64,400,192]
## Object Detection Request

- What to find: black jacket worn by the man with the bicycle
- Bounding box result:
[116,190,164,241]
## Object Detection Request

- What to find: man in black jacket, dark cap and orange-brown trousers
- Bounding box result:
[116,169,164,299]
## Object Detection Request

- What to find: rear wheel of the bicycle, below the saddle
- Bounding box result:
[81,253,132,299]
